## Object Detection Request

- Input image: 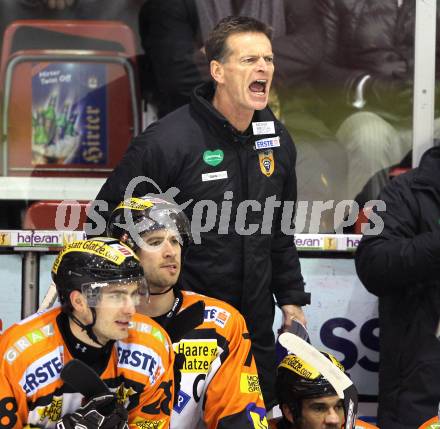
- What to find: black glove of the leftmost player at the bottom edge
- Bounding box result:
[56,394,128,429]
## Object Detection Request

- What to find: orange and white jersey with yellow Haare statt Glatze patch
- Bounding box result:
[156,291,267,429]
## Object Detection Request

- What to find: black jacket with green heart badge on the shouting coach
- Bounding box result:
[96,84,308,307]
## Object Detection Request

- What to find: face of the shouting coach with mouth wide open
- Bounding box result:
[214,33,274,112]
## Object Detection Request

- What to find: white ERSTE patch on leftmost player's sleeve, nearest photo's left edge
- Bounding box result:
[20,346,64,396]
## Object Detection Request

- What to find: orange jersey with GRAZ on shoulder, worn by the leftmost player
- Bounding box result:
[0,308,174,429]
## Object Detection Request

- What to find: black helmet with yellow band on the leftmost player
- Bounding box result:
[52,237,148,311]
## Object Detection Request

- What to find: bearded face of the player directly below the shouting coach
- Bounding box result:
[137,229,181,293]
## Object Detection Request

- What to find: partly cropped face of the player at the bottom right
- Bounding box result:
[301,395,344,429]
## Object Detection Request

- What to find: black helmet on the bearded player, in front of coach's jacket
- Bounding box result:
[107,195,192,250]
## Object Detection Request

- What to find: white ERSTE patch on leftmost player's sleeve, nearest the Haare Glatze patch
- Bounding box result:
[117,341,164,384]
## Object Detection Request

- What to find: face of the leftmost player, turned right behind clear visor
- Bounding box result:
[93,282,141,344]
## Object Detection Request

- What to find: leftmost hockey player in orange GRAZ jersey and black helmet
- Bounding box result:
[0,238,173,429]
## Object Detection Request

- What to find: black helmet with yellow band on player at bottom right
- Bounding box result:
[276,352,345,418]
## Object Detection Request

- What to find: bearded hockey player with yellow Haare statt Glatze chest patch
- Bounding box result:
[107,197,267,429]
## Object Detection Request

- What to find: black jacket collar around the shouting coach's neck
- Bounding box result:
[191,82,281,138]
